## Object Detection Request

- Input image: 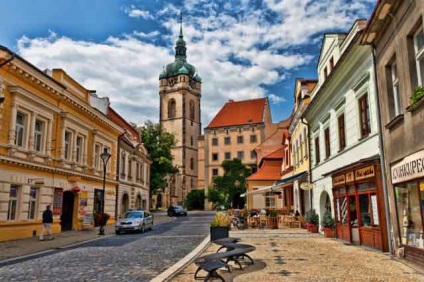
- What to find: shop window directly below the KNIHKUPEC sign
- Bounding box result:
[395,181,424,246]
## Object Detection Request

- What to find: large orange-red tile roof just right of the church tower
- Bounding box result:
[207,98,267,128]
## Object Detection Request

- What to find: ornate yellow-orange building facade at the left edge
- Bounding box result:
[0,46,124,241]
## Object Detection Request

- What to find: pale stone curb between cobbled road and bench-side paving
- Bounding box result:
[150,235,211,282]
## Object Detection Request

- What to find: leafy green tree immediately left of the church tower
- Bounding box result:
[141,120,178,194]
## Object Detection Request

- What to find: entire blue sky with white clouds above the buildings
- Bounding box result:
[0,0,377,127]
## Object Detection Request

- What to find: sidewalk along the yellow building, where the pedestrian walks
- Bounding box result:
[0,213,172,262]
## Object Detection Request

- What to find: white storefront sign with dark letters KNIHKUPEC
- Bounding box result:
[391,150,424,184]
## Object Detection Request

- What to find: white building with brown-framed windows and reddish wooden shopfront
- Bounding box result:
[303,20,387,250]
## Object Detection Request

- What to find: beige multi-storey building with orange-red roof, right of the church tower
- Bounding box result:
[198,98,275,208]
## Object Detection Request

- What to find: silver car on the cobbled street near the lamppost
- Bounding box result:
[115,211,153,235]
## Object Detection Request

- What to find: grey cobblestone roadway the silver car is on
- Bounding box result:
[0,212,213,282]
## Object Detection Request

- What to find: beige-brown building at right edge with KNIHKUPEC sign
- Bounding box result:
[362,0,424,266]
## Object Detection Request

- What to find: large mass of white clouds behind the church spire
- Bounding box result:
[18,0,370,126]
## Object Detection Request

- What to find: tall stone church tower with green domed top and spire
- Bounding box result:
[159,16,202,206]
